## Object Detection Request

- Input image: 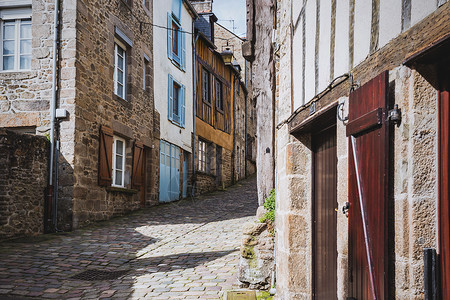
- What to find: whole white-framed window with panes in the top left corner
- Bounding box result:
[0,13,31,71]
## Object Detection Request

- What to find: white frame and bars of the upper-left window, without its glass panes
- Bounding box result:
[0,14,33,72]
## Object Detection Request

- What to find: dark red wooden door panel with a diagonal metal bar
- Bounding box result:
[346,72,389,300]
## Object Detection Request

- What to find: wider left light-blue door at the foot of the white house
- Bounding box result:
[159,141,180,202]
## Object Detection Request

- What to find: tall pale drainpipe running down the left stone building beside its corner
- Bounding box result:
[47,0,59,232]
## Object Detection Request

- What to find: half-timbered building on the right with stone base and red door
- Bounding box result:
[244,0,450,300]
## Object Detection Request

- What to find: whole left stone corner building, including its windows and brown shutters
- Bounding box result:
[0,0,159,230]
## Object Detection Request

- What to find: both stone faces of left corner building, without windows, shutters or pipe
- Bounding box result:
[0,0,159,230]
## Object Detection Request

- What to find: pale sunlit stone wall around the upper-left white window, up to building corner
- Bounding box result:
[0,0,77,230]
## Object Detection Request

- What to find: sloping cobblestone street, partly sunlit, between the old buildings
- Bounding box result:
[0,178,257,299]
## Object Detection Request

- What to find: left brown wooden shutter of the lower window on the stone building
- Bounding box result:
[98,126,113,186]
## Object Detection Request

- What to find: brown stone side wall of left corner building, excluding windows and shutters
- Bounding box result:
[72,0,159,227]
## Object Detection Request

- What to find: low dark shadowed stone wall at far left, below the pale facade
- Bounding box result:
[0,128,50,239]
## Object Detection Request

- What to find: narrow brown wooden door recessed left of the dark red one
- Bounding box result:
[312,125,337,300]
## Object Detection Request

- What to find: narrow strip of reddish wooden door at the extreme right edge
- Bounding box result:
[438,70,450,299]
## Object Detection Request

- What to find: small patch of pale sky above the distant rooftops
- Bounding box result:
[213,0,246,37]
